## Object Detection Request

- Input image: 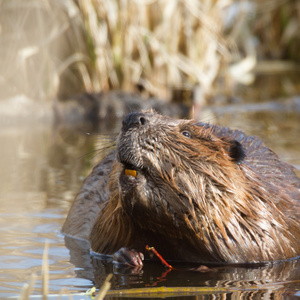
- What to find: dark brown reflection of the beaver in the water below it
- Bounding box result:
[65,231,300,299]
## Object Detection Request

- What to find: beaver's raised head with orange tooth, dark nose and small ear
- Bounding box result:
[117,112,245,224]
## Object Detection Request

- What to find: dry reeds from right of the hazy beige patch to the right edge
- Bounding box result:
[78,0,300,98]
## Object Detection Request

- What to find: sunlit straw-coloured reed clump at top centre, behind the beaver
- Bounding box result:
[78,0,240,98]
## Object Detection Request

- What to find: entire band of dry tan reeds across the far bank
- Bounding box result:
[0,0,300,100]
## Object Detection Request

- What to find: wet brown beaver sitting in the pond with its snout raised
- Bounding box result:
[63,111,300,264]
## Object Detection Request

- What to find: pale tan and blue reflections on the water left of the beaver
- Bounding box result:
[0,123,98,295]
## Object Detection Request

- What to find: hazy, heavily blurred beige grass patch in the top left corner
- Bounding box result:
[0,0,89,102]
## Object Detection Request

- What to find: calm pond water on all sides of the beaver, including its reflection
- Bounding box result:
[0,103,300,299]
